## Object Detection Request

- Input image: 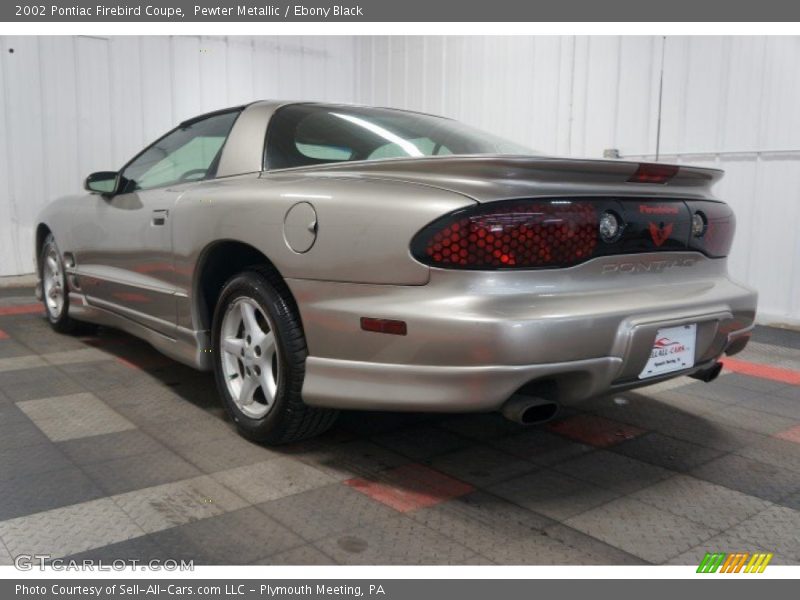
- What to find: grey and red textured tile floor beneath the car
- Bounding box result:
[0,289,800,564]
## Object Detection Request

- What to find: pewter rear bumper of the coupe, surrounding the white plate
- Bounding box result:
[289,253,756,412]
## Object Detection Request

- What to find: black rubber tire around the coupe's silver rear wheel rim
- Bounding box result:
[212,266,338,445]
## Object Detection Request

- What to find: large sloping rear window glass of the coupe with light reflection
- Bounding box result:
[267,104,538,169]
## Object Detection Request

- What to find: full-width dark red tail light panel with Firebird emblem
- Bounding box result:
[411,197,735,270]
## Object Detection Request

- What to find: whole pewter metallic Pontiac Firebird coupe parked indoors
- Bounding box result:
[36,101,756,444]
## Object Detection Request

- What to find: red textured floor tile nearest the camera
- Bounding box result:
[344,464,475,512]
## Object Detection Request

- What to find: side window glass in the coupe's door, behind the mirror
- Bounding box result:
[122,111,239,192]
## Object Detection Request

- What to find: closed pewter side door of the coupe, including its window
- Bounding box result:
[75,111,239,335]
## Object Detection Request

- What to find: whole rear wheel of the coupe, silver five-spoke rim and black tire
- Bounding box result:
[212,267,336,444]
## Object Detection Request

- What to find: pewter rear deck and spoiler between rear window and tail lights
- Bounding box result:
[282,155,723,202]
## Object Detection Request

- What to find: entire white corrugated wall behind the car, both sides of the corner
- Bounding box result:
[0,36,800,324]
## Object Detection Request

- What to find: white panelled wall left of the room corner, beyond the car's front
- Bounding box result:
[0,36,355,276]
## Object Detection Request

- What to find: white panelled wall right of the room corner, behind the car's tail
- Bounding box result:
[356,36,800,324]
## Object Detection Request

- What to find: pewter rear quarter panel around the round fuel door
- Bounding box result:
[172,173,475,293]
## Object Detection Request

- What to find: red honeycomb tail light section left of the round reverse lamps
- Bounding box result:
[412,200,598,269]
